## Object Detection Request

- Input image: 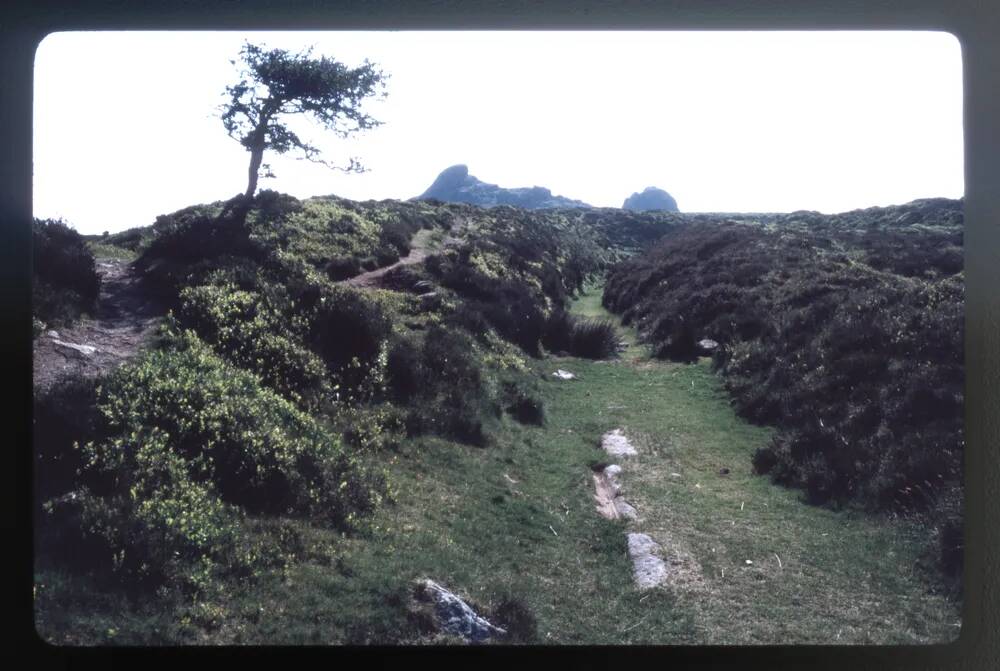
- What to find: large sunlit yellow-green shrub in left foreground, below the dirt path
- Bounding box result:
[39,331,385,589]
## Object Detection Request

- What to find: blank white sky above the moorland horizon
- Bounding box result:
[34,32,964,233]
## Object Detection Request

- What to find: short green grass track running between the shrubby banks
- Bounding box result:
[39,289,959,644]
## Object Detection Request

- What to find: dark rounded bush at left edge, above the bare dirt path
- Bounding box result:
[31,219,100,326]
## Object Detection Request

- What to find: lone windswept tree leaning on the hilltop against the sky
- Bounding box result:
[222,42,388,202]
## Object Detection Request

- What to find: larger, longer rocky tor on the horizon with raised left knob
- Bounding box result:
[416,165,591,210]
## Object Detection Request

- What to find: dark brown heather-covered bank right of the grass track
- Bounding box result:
[605,200,964,576]
